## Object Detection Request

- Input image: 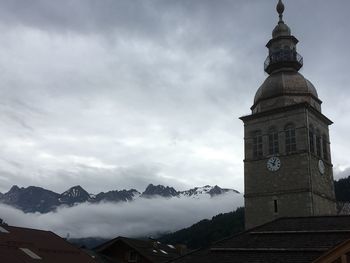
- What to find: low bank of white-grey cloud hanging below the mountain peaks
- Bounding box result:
[0,194,243,238]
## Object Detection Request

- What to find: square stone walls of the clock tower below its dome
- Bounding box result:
[243,104,335,228]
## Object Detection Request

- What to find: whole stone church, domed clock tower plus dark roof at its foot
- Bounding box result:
[171,0,350,263]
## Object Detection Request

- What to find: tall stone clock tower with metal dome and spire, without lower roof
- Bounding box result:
[241,0,336,229]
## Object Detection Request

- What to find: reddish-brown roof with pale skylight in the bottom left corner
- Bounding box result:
[0,225,96,263]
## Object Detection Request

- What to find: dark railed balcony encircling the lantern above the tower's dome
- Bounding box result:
[264,49,303,73]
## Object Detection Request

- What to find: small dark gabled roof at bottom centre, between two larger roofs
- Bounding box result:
[95,237,180,263]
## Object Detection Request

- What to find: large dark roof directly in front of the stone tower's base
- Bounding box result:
[171,216,350,263]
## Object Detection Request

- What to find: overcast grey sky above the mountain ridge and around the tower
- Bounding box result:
[0,0,350,193]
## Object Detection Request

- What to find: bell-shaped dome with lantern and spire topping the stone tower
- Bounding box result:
[251,0,322,113]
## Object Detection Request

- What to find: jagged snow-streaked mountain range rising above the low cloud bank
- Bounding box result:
[0,184,239,213]
